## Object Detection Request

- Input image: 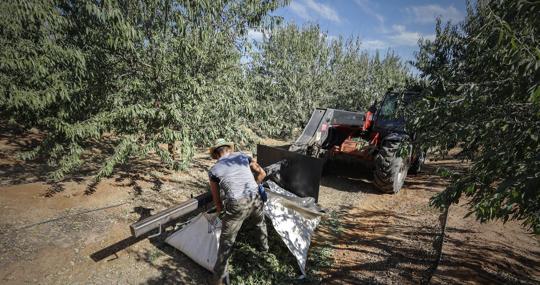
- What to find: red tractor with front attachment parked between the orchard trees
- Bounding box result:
[257,91,425,198]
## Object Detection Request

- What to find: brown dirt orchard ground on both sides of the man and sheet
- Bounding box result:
[0,127,540,284]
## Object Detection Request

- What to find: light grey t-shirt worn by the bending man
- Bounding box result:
[208,152,258,199]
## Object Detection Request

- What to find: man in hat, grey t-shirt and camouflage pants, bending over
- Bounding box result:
[208,139,268,284]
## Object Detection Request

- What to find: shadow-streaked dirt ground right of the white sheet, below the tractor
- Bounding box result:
[316,160,540,284]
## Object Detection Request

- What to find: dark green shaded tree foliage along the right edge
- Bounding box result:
[411,1,540,233]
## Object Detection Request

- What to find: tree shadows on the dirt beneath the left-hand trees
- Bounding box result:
[0,122,207,197]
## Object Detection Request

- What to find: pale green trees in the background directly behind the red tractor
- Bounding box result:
[248,24,409,137]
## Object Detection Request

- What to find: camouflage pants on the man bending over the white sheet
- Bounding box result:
[214,194,268,280]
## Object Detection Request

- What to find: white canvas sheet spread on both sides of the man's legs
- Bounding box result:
[165,181,323,275]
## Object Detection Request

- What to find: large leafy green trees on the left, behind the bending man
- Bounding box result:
[0,0,283,179]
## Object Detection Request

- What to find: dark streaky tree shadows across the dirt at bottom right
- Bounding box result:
[320,205,540,284]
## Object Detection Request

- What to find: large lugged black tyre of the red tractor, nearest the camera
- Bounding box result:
[373,141,408,193]
